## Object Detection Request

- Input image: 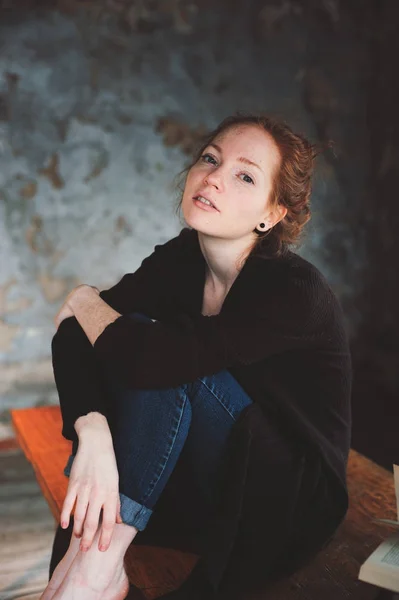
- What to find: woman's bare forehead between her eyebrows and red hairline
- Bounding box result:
[213,125,280,167]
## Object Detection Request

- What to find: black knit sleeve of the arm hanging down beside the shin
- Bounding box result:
[51,230,189,443]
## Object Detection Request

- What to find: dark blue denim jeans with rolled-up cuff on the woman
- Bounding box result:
[64,313,252,531]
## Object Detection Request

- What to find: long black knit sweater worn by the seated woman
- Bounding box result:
[52,229,351,598]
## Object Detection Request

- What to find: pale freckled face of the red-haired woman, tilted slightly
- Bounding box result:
[182,125,282,241]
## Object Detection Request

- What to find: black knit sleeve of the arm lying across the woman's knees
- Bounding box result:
[93,267,332,389]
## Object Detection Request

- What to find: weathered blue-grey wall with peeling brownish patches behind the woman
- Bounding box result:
[0,1,368,435]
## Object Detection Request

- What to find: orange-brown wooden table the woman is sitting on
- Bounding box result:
[11,406,399,600]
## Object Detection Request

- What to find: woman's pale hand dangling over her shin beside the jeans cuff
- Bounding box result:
[60,426,122,550]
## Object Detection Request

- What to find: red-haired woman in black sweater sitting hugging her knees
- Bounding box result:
[42,114,351,600]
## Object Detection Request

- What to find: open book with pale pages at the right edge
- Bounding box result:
[358,465,399,592]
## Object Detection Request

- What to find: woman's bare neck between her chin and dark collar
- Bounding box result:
[198,232,255,293]
